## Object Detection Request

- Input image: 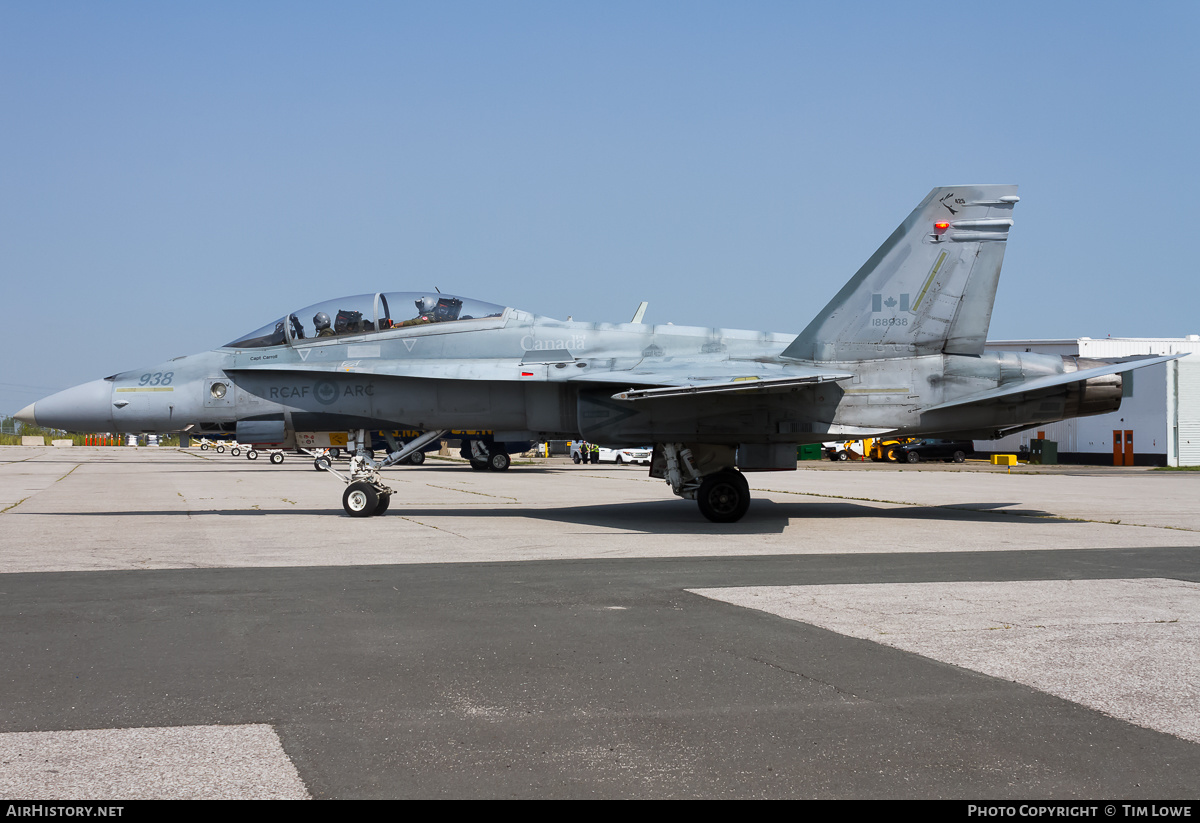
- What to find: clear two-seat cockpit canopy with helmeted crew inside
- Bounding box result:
[226,292,505,349]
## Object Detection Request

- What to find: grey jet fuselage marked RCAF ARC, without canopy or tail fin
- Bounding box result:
[36,310,1120,445]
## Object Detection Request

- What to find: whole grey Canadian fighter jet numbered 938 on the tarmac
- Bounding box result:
[17,185,1171,522]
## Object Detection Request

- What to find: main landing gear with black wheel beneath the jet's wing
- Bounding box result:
[650,443,750,523]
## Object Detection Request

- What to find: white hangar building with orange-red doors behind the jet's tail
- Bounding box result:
[976,335,1200,465]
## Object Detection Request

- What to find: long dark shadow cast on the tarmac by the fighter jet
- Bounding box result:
[25,499,1067,535]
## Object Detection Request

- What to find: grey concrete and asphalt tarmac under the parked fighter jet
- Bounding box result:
[0,446,1200,799]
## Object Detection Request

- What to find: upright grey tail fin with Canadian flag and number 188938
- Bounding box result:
[782,186,1020,360]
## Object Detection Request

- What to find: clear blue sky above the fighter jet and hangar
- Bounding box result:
[0,0,1200,413]
